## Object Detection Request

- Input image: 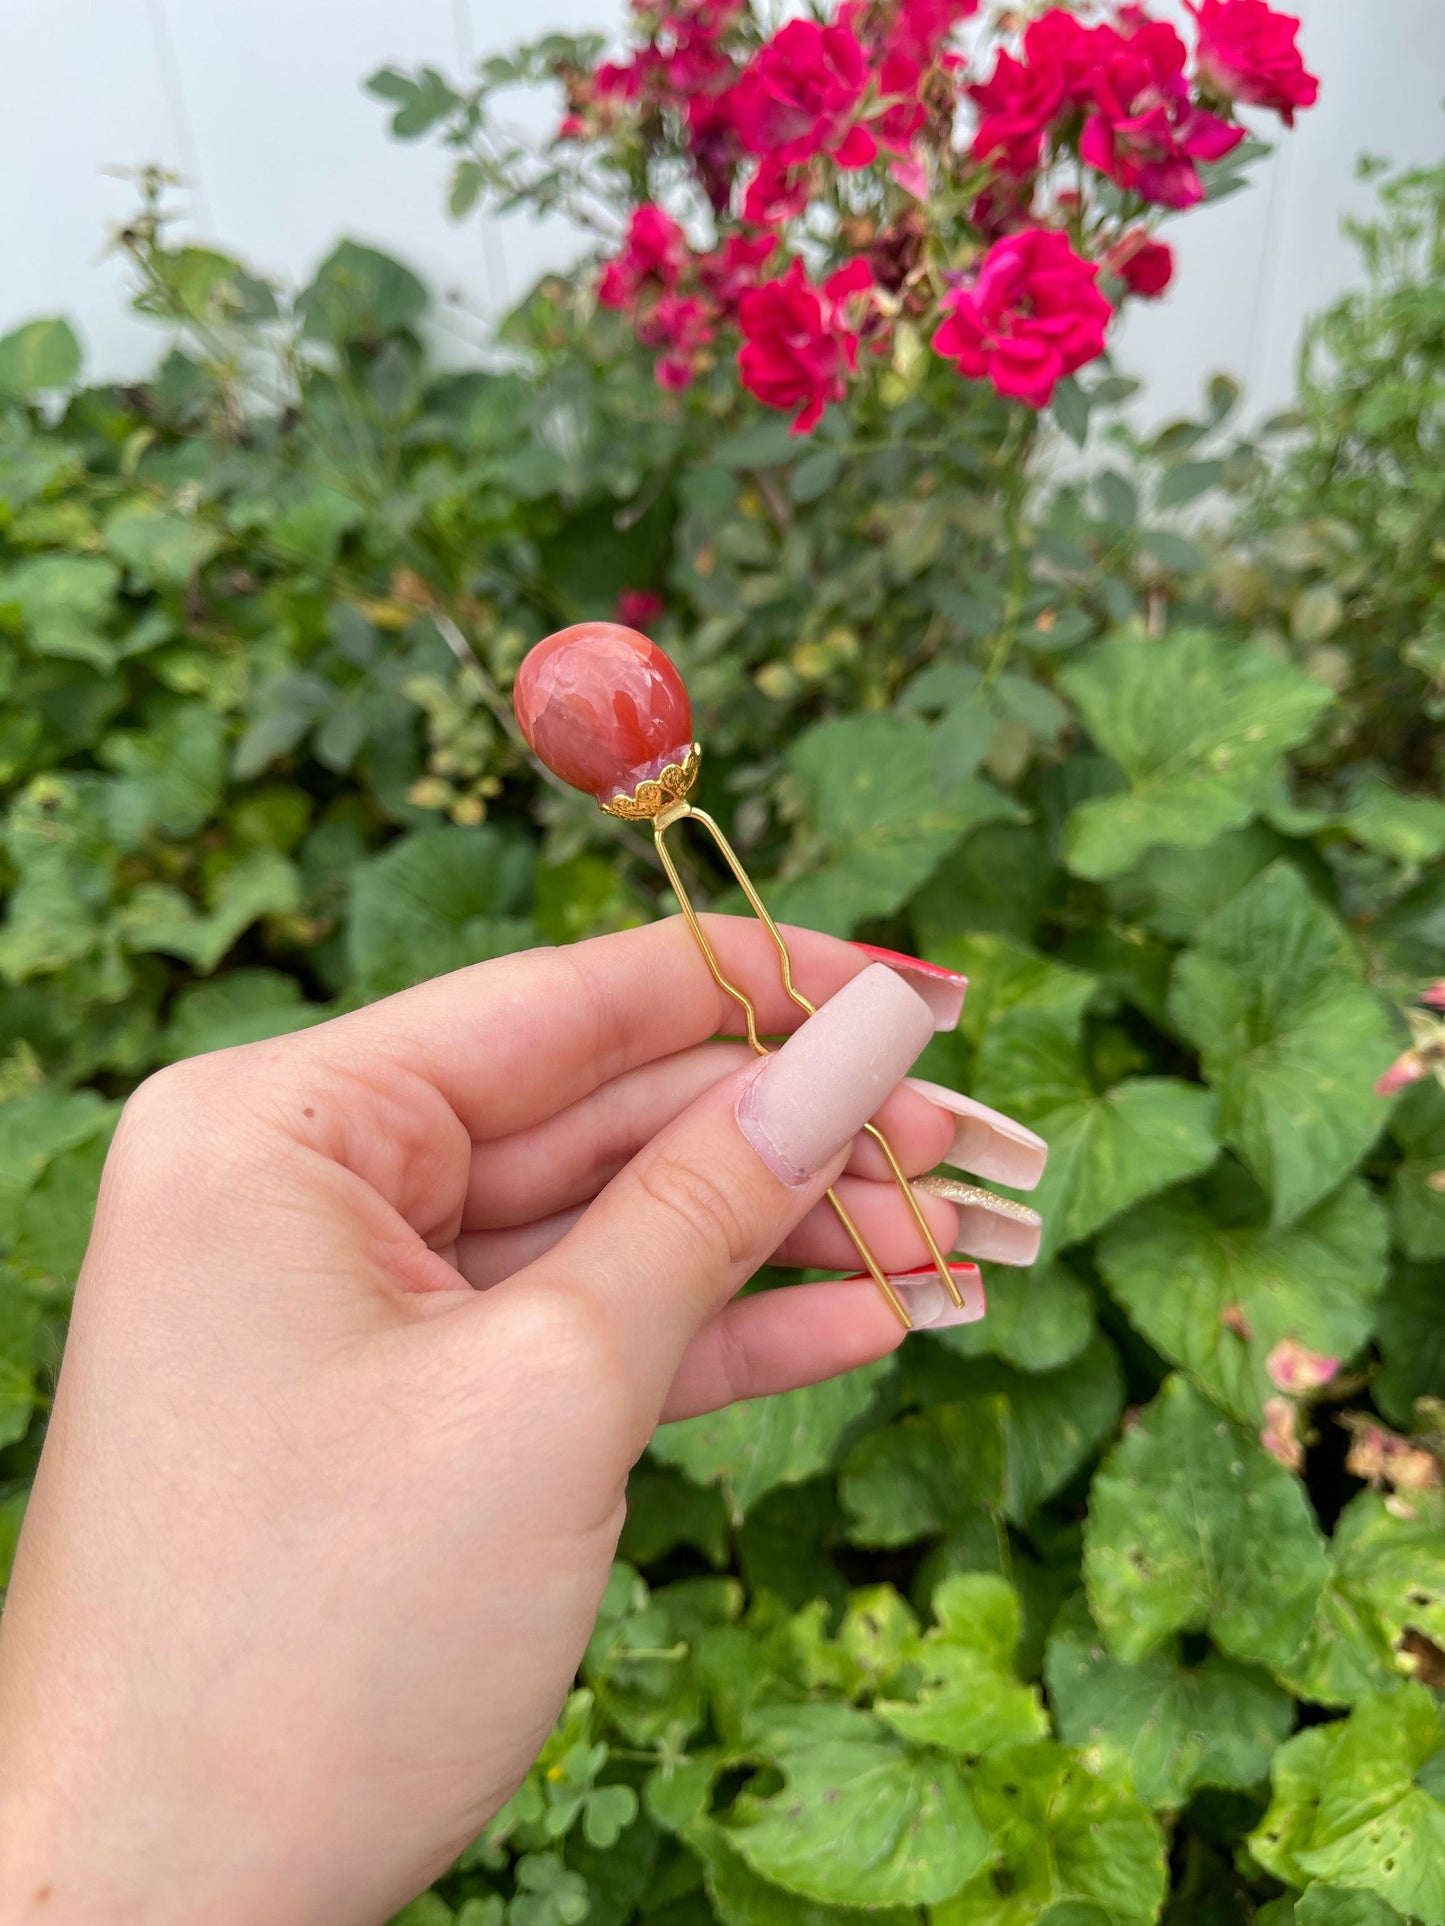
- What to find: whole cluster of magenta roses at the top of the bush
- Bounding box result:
[559,0,1318,433]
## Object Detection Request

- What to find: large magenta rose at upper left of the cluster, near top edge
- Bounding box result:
[732,19,877,168]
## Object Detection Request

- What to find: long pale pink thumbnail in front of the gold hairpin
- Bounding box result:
[736,963,933,1188]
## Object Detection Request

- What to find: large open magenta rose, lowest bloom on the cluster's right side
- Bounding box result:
[933,227,1114,408]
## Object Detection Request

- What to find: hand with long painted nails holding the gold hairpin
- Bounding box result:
[0,919,1042,1926]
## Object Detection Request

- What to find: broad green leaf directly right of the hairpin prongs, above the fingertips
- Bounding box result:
[769,715,1021,936]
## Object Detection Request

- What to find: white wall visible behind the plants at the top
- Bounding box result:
[0,0,1445,425]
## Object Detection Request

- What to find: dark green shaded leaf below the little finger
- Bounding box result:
[838,1398,1004,1547]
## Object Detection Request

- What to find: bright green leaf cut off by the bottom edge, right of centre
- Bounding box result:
[933,1745,1168,1926]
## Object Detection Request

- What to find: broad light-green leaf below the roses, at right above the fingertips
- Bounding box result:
[1060,630,1331,878]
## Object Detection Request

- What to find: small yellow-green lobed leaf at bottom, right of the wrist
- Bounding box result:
[873,1572,1048,1758]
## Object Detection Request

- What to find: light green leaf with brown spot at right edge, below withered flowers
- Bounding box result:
[1281,1491,1445,1705]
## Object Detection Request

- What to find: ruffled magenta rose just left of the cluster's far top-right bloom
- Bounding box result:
[1079,8,1245,208]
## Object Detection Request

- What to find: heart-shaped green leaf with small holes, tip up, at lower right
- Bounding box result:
[1085,1377,1326,1666]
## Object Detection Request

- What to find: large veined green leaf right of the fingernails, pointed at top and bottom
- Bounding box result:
[1169,863,1397,1225]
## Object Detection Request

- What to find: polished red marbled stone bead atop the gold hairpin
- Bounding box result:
[512,622,692,803]
